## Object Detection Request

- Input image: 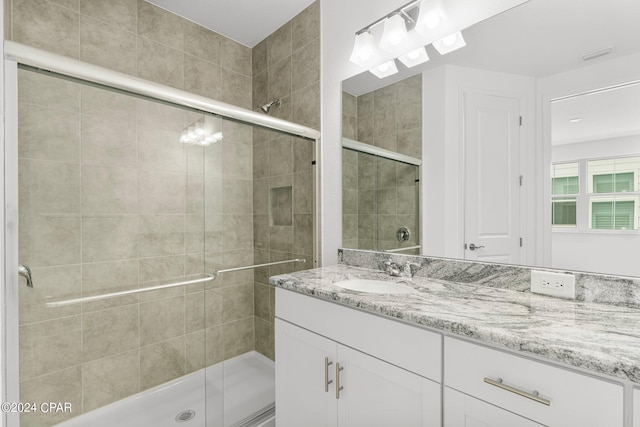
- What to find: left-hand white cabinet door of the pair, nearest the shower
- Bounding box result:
[275,319,337,427]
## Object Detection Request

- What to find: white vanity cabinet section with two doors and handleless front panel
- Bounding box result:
[275,289,442,427]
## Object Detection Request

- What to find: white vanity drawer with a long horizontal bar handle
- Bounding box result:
[444,337,623,427]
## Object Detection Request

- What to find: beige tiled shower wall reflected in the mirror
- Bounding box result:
[342,74,422,250]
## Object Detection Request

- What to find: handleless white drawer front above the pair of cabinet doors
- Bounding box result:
[276,288,442,383]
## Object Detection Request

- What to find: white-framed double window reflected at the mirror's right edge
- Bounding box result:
[551,156,640,230]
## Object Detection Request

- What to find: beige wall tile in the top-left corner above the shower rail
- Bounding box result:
[12,0,80,58]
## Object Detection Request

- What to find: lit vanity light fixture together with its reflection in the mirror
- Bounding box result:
[349,0,466,78]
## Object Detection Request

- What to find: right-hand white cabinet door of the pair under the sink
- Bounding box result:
[338,345,440,427]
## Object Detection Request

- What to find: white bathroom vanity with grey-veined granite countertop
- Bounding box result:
[271,252,640,427]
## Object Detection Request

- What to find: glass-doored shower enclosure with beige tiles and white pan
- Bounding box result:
[4,45,317,427]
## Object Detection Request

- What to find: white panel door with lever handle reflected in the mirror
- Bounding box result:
[464,92,520,263]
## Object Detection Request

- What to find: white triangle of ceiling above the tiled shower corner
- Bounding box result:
[147,0,314,47]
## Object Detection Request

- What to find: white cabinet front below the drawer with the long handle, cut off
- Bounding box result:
[443,387,542,427]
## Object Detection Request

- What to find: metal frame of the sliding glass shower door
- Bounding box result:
[0,41,322,427]
